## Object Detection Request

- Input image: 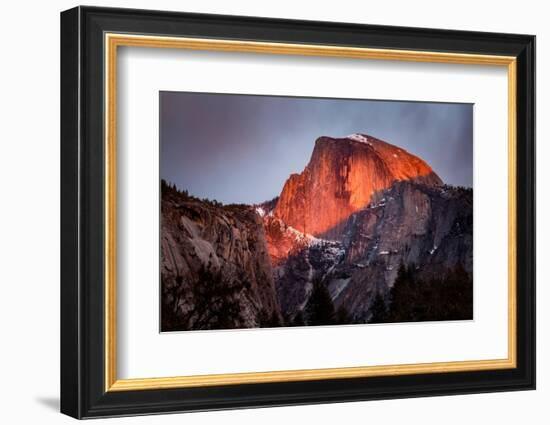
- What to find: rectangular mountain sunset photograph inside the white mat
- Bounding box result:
[159,91,474,332]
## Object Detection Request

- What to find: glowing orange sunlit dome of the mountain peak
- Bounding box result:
[274,134,443,240]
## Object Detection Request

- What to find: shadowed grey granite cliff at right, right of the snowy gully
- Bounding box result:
[325,182,473,320]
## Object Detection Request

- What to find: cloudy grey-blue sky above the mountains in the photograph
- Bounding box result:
[160,92,473,203]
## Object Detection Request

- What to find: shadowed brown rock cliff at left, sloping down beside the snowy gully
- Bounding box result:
[161,184,281,330]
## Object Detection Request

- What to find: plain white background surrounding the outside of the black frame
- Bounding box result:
[0,0,550,424]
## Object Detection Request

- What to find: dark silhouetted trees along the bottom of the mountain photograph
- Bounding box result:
[162,265,473,330]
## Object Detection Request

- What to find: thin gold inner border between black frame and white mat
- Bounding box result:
[104,33,517,391]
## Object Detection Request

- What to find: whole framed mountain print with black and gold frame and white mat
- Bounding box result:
[61,7,535,418]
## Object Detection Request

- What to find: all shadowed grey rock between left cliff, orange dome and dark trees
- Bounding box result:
[266,181,473,323]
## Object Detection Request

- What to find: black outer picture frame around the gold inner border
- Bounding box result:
[61,7,535,418]
